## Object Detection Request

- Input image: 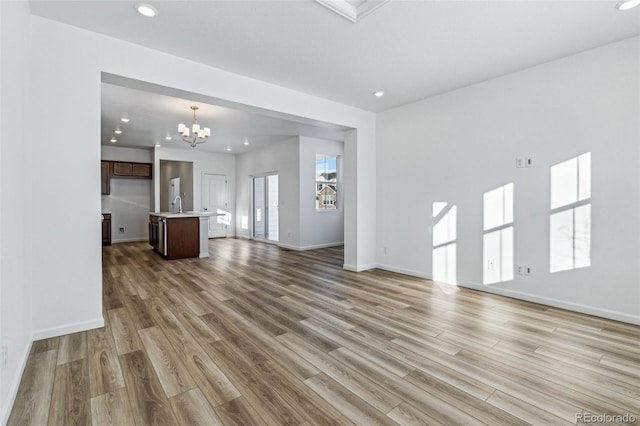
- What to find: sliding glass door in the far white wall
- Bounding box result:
[253,174,280,241]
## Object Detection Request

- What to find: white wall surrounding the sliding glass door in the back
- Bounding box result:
[235,138,300,248]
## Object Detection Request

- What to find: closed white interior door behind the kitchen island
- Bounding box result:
[202,173,231,238]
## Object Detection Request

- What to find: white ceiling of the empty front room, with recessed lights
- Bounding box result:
[30,0,640,111]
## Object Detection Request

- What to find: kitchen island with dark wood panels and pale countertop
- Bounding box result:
[149,211,223,260]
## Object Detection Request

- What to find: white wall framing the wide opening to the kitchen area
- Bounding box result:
[22,13,375,346]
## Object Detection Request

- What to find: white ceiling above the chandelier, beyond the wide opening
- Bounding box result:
[101,79,345,154]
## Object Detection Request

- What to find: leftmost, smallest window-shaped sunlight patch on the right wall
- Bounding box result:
[431,202,457,284]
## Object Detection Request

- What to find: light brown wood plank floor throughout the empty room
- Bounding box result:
[9,239,640,426]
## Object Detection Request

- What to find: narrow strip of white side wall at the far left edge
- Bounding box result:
[0,1,33,424]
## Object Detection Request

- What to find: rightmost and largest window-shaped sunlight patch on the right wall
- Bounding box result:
[549,152,591,272]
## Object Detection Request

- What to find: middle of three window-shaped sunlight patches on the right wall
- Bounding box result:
[482,183,513,284]
